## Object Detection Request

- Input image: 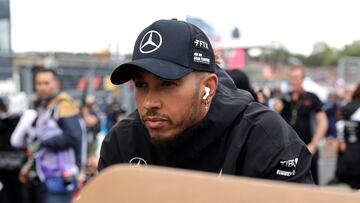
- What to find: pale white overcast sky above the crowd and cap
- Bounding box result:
[10,0,360,55]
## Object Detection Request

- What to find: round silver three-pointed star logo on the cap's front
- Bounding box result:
[140,30,162,54]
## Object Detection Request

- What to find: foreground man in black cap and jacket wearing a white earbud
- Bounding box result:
[98,19,312,183]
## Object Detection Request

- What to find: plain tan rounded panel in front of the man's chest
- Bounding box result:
[74,164,360,203]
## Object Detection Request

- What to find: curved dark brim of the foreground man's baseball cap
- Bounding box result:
[110,58,192,85]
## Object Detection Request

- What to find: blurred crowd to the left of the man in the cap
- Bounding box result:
[0,68,125,203]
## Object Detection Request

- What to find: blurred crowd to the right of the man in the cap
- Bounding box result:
[227,67,360,189]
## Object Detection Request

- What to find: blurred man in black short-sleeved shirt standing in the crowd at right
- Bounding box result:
[276,67,328,184]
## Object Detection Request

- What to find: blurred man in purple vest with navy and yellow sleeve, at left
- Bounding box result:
[12,68,86,202]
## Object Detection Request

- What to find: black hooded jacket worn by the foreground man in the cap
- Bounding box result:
[98,68,312,183]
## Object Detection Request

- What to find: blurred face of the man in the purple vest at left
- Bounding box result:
[35,72,59,99]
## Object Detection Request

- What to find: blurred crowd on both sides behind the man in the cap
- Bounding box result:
[0,64,360,203]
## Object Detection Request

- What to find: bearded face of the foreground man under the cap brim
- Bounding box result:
[134,70,201,142]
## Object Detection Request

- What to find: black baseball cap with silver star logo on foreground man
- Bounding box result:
[110,19,216,85]
